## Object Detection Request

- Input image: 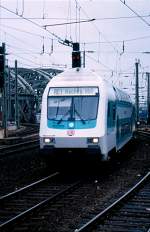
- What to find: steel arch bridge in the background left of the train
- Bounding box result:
[0,68,62,123]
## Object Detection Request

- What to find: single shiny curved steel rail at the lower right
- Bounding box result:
[74,172,150,232]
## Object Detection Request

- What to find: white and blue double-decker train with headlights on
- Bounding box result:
[40,68,135,160]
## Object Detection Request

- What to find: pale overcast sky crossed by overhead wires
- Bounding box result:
[0,0,150,96]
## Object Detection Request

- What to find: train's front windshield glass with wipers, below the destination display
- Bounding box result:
[48,96,99,121]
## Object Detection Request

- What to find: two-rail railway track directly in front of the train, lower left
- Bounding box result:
[0,172,80,231]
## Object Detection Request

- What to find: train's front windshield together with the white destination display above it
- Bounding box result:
[48,87,99,123]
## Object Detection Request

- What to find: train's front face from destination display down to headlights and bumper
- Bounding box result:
[40,86,100,156]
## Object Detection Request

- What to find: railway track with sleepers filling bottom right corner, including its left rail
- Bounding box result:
[74,172,150,232]
